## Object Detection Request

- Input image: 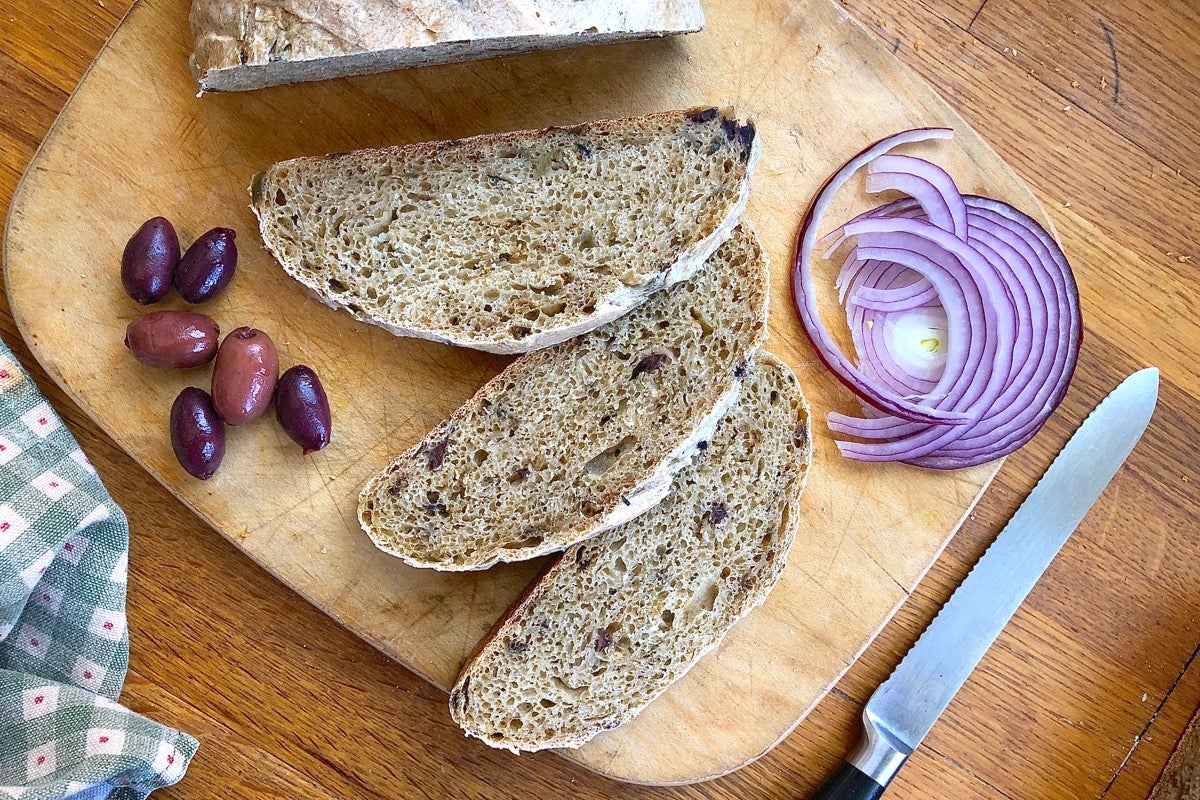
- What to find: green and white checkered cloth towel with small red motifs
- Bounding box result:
[0,343,197,800]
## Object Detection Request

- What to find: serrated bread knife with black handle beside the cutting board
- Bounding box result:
[811,367,1158,800]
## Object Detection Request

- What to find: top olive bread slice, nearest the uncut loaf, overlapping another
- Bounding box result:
[251,109,758,353]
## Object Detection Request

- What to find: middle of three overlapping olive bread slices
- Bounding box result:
[359,228,767,570]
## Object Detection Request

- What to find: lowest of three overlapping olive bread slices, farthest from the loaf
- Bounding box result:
[450,353,811,752]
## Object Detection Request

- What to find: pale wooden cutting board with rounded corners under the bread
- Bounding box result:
[5,0,1045,783]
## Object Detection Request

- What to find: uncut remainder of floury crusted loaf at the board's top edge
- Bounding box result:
[190,0,704,91]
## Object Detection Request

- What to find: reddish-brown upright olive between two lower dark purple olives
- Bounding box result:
[212,326,280,425]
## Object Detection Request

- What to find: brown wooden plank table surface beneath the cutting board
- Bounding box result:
[0,0,1200,800]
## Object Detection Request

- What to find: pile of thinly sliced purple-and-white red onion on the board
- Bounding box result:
[792,128,1082,469]
